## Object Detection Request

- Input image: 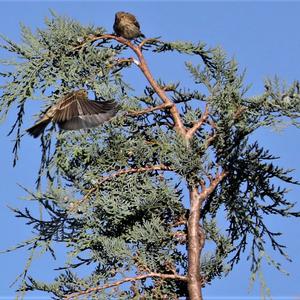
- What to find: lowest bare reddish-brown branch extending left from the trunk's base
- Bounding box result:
[63,272,187,300]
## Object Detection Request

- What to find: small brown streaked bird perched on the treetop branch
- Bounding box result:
[114,11,145,40]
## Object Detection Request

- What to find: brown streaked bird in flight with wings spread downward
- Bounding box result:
[27,90,118,138]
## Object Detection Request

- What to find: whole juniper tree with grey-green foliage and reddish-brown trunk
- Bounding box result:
[0,15,300,299]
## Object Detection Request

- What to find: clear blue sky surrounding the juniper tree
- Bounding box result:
[0,1,300,299]
